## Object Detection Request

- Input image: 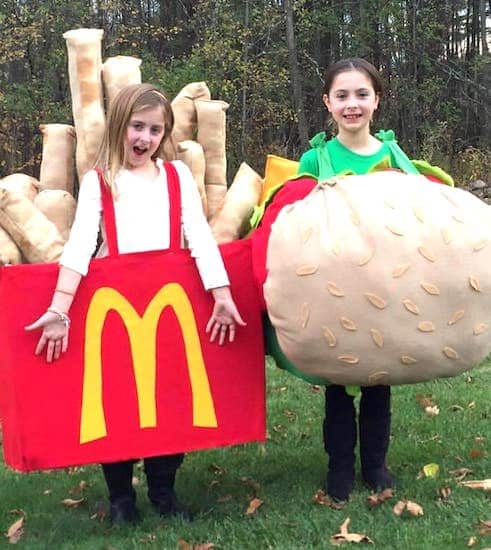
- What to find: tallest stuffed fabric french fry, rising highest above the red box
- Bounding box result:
[63,29,105,181]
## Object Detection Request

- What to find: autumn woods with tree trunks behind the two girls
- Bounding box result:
[0,0,491,188]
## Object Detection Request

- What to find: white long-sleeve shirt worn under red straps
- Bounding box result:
[60,159,229,289]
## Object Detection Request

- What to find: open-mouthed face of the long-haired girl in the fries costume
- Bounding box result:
[124,107,165,168]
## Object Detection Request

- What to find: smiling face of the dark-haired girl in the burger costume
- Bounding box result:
[322,69,379,138]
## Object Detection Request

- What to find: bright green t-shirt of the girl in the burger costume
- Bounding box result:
[298,137,395,177]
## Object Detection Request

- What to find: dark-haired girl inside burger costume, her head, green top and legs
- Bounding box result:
[298,58,453,501]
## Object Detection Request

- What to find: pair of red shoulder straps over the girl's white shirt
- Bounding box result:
[96,162,181,257]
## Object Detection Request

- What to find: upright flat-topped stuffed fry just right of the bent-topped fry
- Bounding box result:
[195,100,228,219]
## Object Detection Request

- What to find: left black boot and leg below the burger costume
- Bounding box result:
[324,385,356,502]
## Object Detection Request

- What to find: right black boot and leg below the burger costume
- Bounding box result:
[358,386,394,492]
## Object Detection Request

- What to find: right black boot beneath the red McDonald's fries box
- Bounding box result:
[144,454,191,521]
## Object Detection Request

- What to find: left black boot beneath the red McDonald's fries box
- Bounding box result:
[101,460,140,523]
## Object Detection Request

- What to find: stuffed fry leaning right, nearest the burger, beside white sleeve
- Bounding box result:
[210,162,263,244]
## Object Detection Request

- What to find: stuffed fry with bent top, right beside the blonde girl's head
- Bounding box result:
[171,82,211,143]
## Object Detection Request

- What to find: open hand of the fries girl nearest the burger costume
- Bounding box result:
[206,287,246,346]
